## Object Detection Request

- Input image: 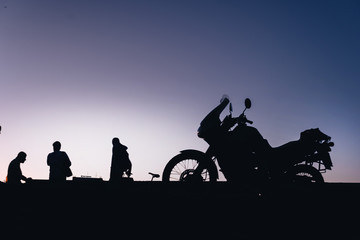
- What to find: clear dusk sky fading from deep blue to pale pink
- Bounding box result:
[0,0,360,182]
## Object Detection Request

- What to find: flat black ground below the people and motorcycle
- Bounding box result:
[0,179,360,239]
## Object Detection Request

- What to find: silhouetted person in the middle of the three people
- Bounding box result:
[47,141,72,183]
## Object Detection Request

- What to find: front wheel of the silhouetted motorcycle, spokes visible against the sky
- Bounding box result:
[162,153,217,182]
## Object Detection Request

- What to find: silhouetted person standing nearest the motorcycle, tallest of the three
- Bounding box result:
[110,137,132,181]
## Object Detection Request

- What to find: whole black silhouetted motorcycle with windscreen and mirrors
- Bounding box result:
[162,95,334,183]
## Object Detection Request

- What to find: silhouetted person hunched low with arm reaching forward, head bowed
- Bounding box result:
[6,152,31,185]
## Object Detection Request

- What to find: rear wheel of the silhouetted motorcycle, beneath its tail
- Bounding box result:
[287,164,325,183]
